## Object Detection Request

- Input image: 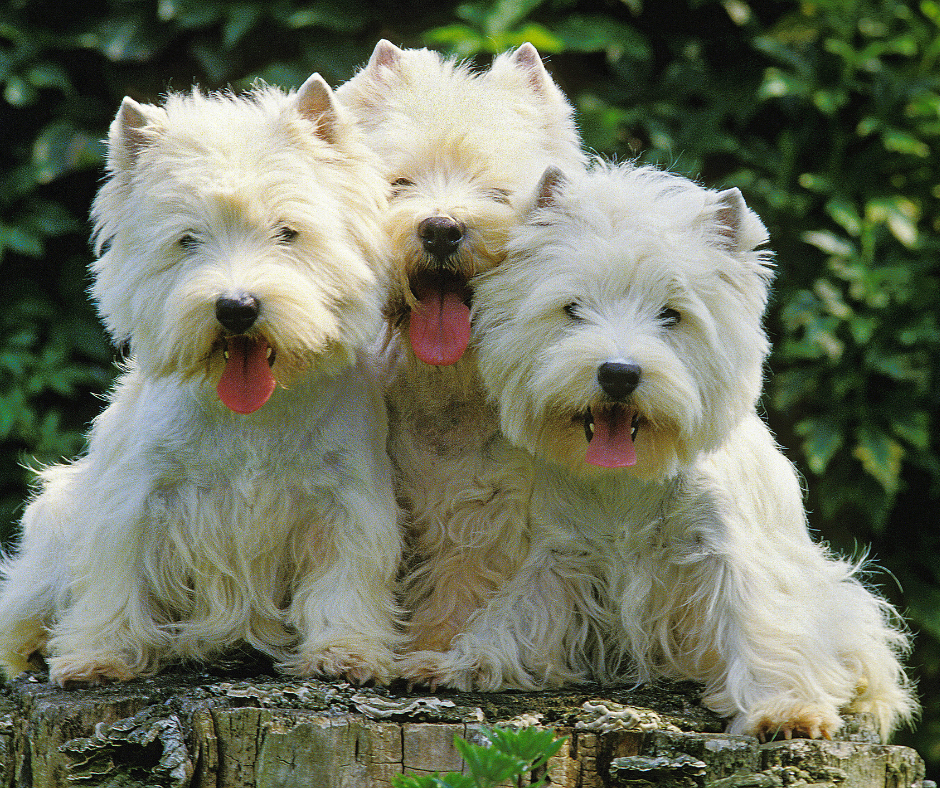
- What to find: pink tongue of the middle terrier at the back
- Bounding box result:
[409,290,470,367]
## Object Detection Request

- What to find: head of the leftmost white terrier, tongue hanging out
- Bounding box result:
[84,75,386,412]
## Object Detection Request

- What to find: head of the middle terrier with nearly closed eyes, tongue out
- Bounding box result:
[337,41,582,366]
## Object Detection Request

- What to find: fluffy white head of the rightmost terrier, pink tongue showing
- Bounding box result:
[475,163,770,478]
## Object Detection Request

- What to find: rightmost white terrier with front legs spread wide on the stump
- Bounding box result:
[414,163,915,738]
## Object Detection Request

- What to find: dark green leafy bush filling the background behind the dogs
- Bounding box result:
[0,0,940,776]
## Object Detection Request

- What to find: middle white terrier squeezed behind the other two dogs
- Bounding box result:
[336,41,584,660]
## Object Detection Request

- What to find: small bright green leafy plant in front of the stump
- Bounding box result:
[392,728,564,788]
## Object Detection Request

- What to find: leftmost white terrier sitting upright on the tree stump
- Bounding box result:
[0,75,401,685]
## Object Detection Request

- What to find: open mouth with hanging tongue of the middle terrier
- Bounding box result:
[408,271,472,367]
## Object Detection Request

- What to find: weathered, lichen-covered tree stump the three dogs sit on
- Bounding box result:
[0,660,935,788]
